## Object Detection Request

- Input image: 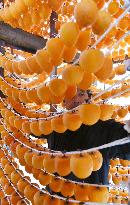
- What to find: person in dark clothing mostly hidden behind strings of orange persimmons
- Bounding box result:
[40,90,130,184]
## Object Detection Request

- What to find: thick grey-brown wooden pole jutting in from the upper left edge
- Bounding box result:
[0,21,47,53]
